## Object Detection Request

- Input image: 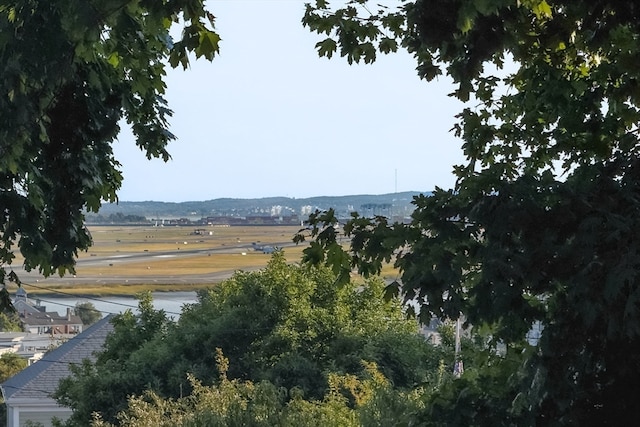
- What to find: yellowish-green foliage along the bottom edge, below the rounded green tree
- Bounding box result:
[86,349,424,427]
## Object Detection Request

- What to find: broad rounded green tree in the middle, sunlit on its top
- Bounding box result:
[57,253,443,425]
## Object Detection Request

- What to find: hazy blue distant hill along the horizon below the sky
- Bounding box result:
[87,191,430,219]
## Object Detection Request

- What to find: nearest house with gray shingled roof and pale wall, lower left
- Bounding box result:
[0,315,113,427]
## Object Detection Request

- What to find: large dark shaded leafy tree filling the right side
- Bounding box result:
[297,0,640,425]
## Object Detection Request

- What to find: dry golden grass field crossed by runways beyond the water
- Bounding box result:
[14,226,395,295]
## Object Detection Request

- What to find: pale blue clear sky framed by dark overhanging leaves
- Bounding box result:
[114,0,463,202]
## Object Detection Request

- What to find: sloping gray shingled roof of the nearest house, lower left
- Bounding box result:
[0,315,113,401]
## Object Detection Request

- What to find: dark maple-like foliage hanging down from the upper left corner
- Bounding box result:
[0,0,219,296]
